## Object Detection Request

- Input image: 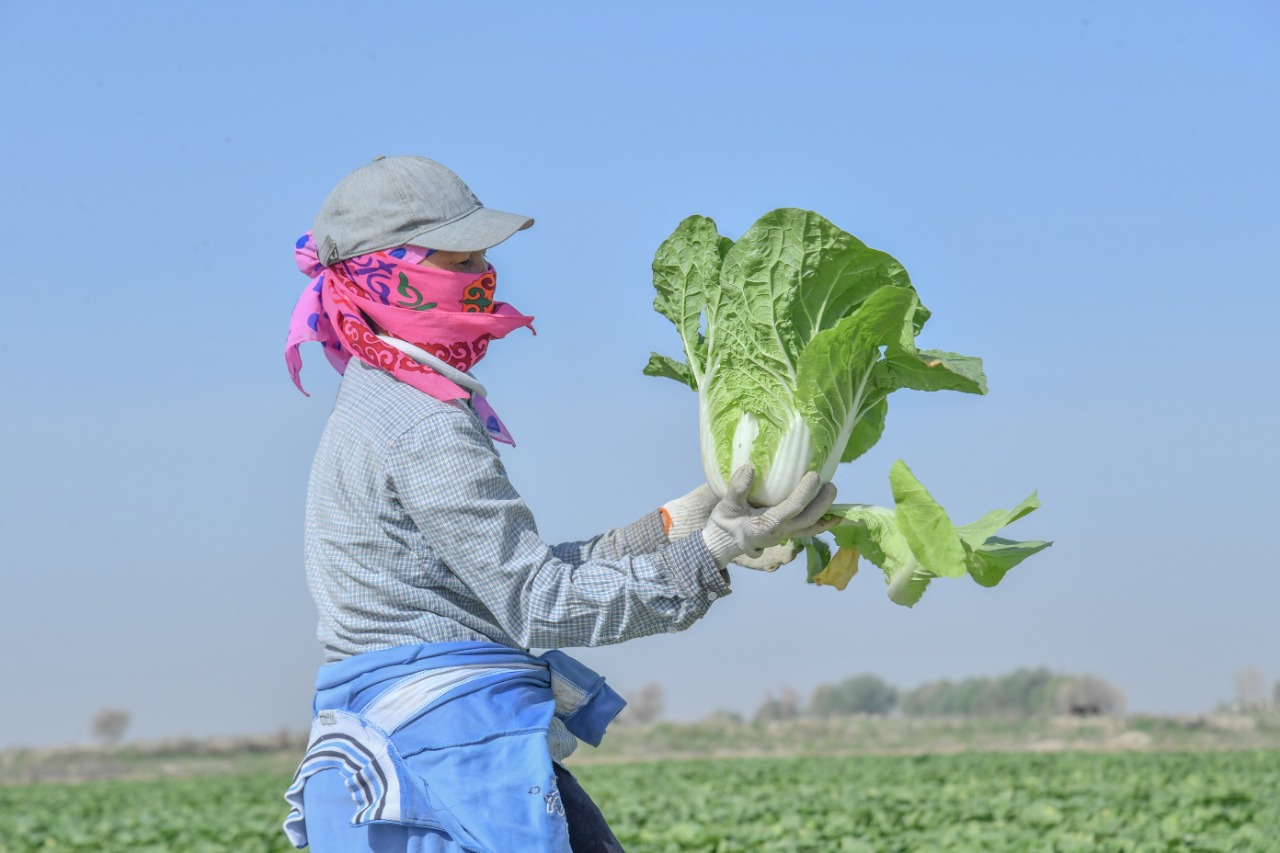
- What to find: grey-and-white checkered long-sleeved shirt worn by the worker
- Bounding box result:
[306,359,730,661]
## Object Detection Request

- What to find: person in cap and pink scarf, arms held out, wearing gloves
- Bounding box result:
[284,156,835,853]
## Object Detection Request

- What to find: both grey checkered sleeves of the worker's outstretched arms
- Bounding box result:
[384,407,730,648]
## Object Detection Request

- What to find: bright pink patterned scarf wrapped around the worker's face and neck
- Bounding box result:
[284,232,534,444]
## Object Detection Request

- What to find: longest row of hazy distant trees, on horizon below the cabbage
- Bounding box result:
[754,667,1124,722]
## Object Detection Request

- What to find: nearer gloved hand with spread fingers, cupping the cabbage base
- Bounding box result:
[703,465,836,569]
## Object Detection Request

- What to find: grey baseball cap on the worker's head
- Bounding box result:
[311,156,534,266]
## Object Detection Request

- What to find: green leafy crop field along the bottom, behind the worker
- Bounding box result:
[0,751,1280,853]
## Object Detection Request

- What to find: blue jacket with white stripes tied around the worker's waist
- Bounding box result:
[284,642,625,853]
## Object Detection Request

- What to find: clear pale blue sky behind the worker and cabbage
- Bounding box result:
[0,1,1280,747]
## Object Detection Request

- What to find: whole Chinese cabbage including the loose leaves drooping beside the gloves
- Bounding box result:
[645,207,1048,605]
